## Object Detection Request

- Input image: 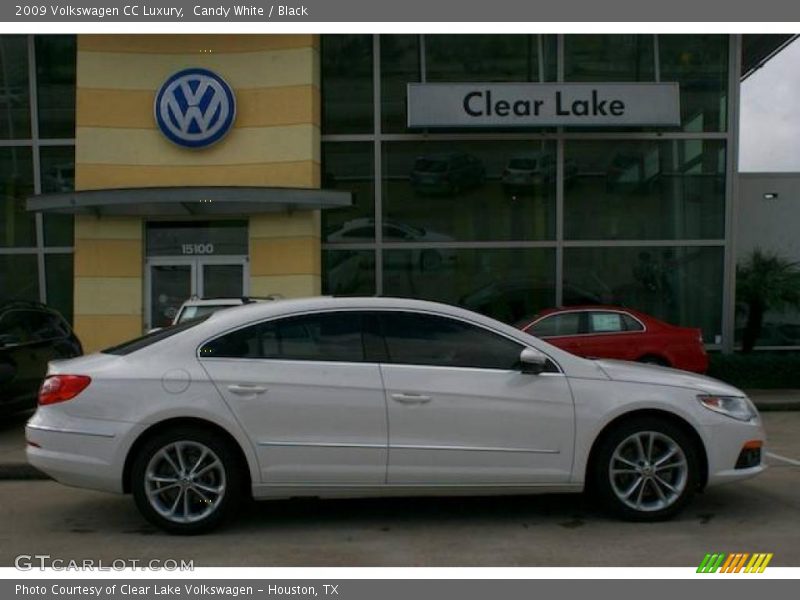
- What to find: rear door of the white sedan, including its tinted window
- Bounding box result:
[200,311,387,485]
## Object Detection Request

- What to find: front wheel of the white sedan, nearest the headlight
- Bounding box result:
[589,417,700,521]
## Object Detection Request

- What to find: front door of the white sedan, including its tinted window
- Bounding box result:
[380,311,574,486]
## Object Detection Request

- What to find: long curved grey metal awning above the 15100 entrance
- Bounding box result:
[27,186,352,217]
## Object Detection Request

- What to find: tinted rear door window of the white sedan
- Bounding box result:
[200,312,365,362]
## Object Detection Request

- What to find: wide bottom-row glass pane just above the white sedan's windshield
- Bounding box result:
[383,248,555,323]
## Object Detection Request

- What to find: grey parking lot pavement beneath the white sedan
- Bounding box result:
[0,412,800,566]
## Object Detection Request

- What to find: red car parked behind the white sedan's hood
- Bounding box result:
[519,306,708,373]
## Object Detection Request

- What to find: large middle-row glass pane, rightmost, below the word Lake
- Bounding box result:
[564,140,725,240]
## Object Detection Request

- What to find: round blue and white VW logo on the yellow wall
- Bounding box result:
[154,68,236,148]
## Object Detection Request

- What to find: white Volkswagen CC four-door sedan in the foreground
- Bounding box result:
[26,298,764,533]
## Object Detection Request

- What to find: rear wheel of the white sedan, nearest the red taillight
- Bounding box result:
[131,427,245,535]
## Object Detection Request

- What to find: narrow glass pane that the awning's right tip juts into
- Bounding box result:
[322,142,375,243]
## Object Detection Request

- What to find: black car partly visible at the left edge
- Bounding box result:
[0,301,83,414]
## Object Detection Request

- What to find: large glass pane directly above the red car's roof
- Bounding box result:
[564,247,723,342]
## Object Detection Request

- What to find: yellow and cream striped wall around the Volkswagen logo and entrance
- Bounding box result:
[75,35,320,351]
